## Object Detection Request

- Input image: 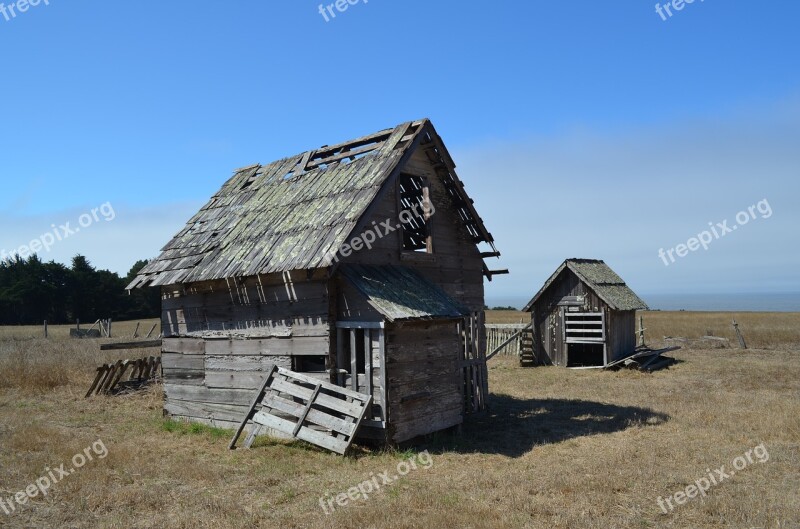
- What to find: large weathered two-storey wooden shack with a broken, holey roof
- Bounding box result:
[128,120,505,443]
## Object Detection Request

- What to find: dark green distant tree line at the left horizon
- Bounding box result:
[0,255,161,325]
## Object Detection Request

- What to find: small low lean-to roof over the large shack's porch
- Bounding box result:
[342,265,469,322]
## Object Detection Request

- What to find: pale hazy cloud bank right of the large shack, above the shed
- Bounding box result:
[451,96,800,298]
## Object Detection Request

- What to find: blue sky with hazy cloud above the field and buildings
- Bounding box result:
[0,0,800,306]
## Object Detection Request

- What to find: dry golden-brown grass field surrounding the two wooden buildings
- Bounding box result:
[0,312,800,529]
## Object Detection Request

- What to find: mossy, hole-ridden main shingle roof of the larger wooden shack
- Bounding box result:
[128,119,493,289]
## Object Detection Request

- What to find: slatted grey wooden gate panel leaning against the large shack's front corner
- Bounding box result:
[228,366,372,455]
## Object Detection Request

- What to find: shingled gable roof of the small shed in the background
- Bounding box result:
[523,259,648,312]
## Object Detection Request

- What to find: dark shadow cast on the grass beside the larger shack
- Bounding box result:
[429,395,669,457]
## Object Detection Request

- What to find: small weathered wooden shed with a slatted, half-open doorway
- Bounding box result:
[523,259,647,367]
